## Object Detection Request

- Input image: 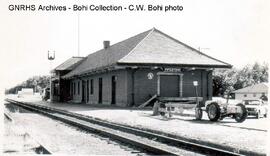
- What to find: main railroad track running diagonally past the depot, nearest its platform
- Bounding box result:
[6,99,263,155]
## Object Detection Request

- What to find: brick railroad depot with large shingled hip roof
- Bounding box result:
[52,28,231,106]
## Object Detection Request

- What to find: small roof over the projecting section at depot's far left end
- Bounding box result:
[53,56,84,71]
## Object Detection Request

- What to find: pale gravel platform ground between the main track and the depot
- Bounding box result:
[4,96,267,155]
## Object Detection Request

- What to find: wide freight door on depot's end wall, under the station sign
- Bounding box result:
[160,75,179,97]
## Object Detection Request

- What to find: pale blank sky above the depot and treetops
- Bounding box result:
[0,0,270,88]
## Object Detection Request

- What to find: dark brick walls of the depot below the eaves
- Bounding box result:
[70,68,212,106]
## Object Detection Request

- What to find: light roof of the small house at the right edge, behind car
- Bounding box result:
[233,83,268,93]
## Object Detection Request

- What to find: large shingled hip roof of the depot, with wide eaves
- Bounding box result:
[64,28,232,78]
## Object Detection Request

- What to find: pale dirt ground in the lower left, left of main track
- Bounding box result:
[3,103,144,155]
